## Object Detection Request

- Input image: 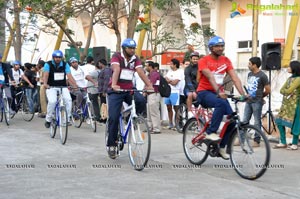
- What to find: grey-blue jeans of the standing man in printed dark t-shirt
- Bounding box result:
[243,100,263,143]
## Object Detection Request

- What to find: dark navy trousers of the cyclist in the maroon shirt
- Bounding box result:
[107,92,146,146]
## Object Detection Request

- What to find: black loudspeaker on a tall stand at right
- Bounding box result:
[261,42,281,70]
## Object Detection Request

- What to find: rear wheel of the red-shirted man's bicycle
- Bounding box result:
[183,118,208,165]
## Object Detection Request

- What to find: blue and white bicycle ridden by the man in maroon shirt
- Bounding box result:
[105,89,153,171]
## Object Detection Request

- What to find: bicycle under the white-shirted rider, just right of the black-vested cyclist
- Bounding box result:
[72,88,97,132]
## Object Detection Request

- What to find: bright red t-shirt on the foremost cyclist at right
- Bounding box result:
[197,55,233,92]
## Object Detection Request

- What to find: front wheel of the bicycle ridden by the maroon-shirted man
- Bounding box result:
[128,116,151,171]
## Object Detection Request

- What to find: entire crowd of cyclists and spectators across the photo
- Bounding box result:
[0,36,300,159]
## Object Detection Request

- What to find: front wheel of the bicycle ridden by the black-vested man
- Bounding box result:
[59,106,69,144]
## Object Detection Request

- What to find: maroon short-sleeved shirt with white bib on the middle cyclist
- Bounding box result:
[110,52,143,89]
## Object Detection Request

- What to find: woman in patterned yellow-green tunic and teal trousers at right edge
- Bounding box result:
[274,61,300,150]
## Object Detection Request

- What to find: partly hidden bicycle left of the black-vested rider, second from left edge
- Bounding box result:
[11,85,34,122]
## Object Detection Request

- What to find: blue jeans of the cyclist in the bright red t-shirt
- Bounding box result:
[197,91,234,148]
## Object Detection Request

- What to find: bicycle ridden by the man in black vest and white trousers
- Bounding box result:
[50,86,68,145]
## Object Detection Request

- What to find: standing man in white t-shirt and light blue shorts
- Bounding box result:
[165,59,183,130]
